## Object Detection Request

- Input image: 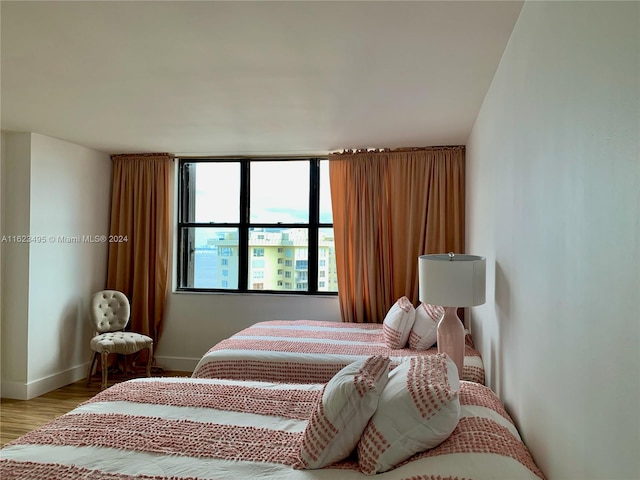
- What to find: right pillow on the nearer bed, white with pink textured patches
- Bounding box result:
[358,354,460,475]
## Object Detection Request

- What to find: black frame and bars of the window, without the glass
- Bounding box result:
[176,156,338,296]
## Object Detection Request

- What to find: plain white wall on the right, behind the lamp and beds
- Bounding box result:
[467,2,640,480]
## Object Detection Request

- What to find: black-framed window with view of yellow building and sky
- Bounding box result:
[177,158,338,294]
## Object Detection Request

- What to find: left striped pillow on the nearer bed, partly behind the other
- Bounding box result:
[295,355,390,469]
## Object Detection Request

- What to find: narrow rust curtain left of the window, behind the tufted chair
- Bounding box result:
[107,154,174,343]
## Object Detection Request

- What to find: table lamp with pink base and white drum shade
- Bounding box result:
[418,253,486,378]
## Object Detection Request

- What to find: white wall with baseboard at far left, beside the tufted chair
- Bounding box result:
[2,133,111,398]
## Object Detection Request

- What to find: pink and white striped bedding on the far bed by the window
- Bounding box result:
[193,320,484,384]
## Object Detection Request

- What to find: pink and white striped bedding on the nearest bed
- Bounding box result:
[0,378,543,480]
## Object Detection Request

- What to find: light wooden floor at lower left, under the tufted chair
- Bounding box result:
[0,371,191,445]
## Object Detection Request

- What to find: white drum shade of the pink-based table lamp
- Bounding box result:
[418,254,486,307]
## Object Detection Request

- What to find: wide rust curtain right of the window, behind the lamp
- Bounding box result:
[329,147,465,323]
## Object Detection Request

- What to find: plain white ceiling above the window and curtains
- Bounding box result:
[0,0,522,155]
